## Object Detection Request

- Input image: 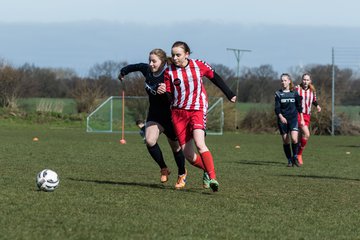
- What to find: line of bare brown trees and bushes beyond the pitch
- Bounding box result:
[0,60,360,112]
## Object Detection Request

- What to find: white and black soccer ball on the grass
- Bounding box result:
[36,169,60,192]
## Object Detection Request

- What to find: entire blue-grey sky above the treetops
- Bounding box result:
[0,0,360,75]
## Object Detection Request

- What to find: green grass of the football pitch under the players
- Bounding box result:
[0,124,360,239]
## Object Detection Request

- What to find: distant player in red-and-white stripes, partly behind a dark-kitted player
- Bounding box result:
[296,73,321,165]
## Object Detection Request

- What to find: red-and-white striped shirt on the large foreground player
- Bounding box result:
[164,59,214,112]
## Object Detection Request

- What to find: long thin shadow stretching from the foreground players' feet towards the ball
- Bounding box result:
[68,178,211,194]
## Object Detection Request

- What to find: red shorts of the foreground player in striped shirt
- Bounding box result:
[171,108,206,145]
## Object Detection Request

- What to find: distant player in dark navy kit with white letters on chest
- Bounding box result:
[275,73,304,167]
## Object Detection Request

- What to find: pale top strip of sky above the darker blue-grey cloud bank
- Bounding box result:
[0,0,360,27]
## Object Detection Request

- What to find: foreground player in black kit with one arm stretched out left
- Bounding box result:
[119,49,186,188]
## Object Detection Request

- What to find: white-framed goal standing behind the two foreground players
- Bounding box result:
[86,96,224,135]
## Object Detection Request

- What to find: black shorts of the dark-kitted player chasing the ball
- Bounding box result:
[146,110,177,141]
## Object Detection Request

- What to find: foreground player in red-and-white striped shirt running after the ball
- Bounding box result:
[164,41,236,192]
